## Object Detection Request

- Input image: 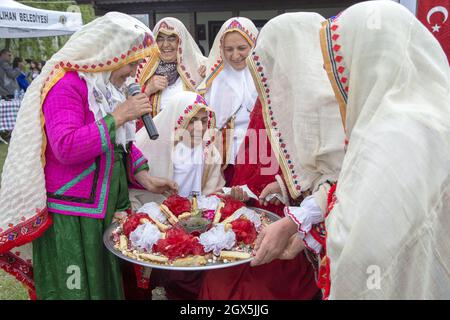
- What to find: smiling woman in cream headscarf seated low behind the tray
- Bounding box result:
[130,92,225,300]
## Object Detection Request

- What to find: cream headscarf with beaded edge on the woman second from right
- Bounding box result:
[247,12,344,199]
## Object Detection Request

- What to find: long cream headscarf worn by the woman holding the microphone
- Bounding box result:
[0,12,157,284]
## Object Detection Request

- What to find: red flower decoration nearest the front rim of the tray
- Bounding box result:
[153,227,205,260]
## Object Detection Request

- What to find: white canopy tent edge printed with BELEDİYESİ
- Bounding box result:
[0,0,83,38]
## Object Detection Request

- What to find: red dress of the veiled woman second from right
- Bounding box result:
[199,99,318,300]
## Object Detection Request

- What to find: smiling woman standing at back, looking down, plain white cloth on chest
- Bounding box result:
[197,17,258,183]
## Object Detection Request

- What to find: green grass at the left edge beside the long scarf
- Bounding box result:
[0,143,28,300]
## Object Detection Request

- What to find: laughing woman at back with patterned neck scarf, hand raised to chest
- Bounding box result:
[136,17,206,117]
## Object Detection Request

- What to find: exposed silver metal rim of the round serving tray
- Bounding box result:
[103,207,281,271]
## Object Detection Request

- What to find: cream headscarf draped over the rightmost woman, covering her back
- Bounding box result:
[321,1,450,299]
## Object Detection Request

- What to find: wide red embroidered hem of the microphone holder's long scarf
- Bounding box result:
[0,207,52,253]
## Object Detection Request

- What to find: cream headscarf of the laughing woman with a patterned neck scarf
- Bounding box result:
[136,17,207,116]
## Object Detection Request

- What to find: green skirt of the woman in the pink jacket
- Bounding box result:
[33,148,130,300]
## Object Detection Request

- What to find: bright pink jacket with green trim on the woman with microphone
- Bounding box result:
[43,72,147,218]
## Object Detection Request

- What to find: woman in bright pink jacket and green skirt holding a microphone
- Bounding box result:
[0,12,176,299]
